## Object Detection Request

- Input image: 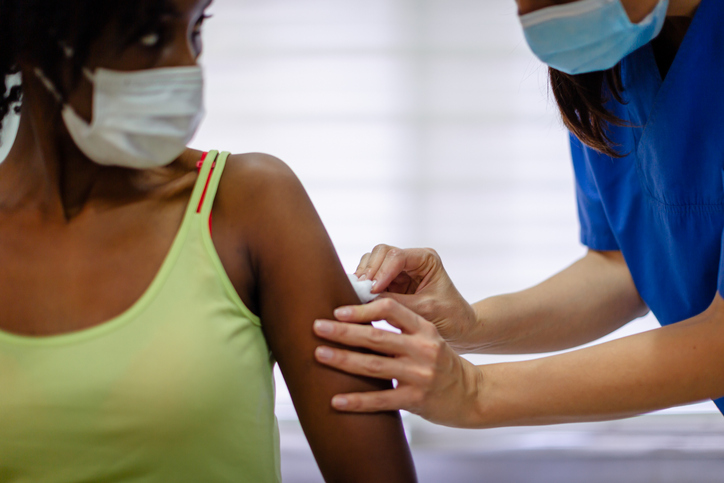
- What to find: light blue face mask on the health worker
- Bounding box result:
[520,0,669,74]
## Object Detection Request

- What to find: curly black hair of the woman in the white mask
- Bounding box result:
[0,0,176,136]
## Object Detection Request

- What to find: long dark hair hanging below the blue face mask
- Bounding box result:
[548,64,628,158]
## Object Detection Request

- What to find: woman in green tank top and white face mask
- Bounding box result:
[0,0,415,482]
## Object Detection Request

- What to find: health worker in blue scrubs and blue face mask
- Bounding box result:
[315,0,724,428]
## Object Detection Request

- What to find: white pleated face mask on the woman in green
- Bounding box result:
[36,66,204,169]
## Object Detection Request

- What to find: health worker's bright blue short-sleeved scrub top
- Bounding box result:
[571,0,724,412]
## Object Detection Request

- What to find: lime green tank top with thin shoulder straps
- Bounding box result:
[0,151,281,483]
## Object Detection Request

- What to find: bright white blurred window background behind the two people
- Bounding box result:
[0,0,724,483]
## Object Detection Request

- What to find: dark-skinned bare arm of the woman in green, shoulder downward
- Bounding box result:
[213,155,416,482]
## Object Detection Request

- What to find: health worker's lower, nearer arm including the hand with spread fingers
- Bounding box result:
[315,295,724,428]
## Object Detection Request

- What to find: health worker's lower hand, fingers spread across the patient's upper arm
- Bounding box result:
[314,298,479,425]
